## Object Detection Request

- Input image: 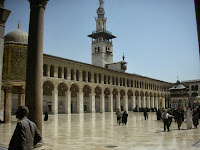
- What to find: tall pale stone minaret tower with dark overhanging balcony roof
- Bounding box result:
[88,0,116,67]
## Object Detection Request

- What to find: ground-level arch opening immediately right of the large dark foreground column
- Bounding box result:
[43,81,55,113]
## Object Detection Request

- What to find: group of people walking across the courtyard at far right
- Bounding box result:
[160,107,200,131]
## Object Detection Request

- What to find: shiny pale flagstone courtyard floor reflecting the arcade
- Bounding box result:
[0,112,200,150]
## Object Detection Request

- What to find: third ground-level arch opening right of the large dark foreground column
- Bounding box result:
[70,84,79,113]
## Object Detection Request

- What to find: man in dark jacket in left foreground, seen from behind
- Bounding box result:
[8,106,42,150]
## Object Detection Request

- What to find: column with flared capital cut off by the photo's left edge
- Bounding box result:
[0,0,10,113]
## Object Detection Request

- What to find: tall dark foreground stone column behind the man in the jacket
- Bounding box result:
[26,0,47,133]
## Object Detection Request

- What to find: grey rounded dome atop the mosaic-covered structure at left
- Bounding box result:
[4,29,28,44]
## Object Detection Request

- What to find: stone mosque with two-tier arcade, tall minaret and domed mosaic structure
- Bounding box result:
[1,0,200,121]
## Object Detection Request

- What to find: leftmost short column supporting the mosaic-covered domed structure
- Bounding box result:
[4,86,12,123]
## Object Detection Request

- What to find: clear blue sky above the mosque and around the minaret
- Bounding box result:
[4,0,200,83]
